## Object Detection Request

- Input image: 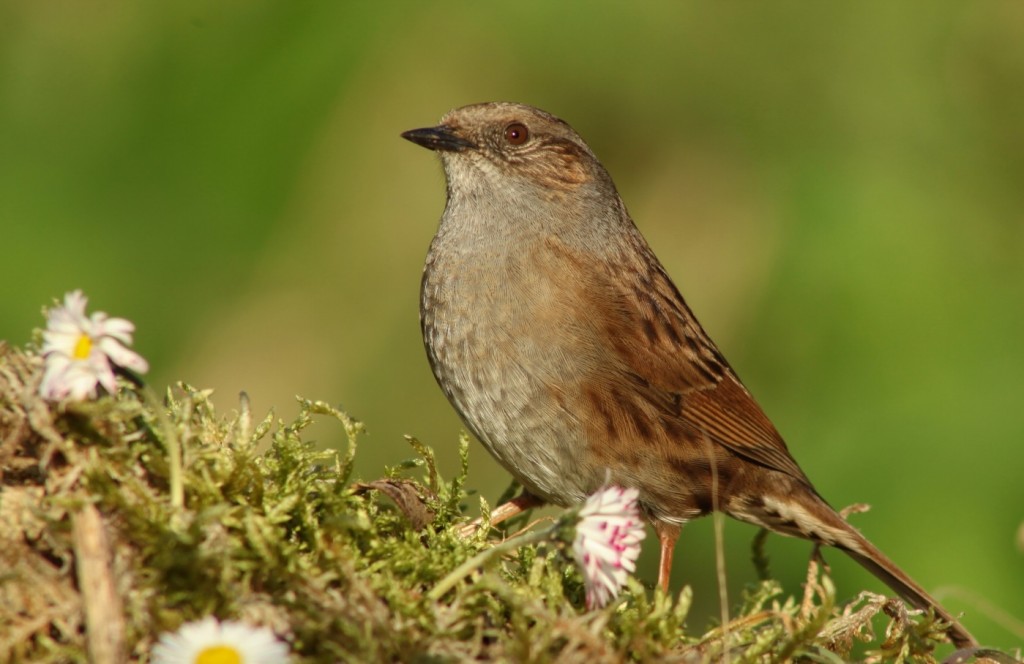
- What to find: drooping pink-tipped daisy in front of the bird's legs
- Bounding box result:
[572,487,647,609]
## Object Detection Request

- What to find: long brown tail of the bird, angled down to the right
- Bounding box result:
[749,487,978,648]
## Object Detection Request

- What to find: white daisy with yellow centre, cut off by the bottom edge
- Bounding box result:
[151,617,289,664]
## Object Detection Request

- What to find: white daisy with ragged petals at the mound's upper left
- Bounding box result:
[39,290,150,401]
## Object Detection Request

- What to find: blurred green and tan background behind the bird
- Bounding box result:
[0,0,1024,647]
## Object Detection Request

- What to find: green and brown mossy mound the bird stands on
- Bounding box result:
[0,343,1007,664]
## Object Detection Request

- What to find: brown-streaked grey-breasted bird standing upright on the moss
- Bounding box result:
[401,101,977,648]
